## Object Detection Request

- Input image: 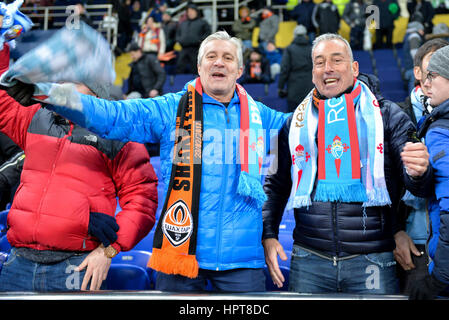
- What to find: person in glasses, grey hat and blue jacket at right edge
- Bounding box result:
[410,45,449,299]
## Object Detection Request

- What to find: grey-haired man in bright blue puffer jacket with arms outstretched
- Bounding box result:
[3,31,288,292]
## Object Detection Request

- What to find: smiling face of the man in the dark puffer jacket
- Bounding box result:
[312,39,359,98]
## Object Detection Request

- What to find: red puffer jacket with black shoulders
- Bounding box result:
[0,90,157,251]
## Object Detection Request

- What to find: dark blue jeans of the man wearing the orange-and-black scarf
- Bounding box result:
[156,269,265,292]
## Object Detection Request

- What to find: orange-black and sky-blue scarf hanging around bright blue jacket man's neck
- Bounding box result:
[149,78,266,278]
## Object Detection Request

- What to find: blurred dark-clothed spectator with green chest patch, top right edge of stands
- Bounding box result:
[373,0,401,49]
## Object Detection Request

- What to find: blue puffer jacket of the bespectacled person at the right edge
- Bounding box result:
[421,100,449,283]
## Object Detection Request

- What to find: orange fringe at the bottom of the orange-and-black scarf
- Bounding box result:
[148,248,199,279]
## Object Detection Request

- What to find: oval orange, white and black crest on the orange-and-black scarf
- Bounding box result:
[162,200,193,247]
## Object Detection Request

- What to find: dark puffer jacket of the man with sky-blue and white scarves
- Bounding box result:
[262,75,432,257]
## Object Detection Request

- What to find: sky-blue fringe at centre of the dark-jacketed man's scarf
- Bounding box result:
[314,181,367,202]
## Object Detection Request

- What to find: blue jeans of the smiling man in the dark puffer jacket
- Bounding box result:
[289,245,399,294]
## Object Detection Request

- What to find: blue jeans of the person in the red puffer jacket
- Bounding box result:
[0,248,92,292]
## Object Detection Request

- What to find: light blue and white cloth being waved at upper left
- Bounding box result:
[0,22,115,105]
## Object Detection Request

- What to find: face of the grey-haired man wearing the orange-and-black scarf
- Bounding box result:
[198,40,243,102]
